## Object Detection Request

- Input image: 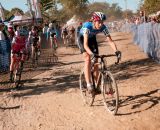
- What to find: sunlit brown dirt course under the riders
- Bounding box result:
[0,33,160,130]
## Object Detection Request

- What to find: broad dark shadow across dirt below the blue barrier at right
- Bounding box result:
[109,58,160,80]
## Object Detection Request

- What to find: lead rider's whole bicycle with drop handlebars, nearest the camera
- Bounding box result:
[79,54,120,115]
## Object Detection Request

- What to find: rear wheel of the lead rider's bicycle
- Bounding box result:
[79,71,95,106]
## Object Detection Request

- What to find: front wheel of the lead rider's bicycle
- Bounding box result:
[102,71,119,115]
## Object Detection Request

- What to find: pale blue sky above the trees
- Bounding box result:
[0,0,140,12]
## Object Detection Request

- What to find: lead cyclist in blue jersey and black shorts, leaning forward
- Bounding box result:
[78,12,121,93]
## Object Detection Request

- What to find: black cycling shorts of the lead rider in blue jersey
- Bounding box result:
[78,35,99,54]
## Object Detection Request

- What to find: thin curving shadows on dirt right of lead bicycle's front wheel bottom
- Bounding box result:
[118,89,160,115]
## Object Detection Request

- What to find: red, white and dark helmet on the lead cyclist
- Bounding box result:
[92,12,106,21]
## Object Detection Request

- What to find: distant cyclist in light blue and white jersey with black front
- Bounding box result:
[47,23,58,49]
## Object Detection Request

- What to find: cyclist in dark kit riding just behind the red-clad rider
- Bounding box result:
[28,26,41,61]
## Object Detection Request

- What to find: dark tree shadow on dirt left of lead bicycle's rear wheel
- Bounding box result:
[9,69,79,97]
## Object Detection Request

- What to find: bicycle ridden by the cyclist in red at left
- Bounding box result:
[12,52,27,88]
